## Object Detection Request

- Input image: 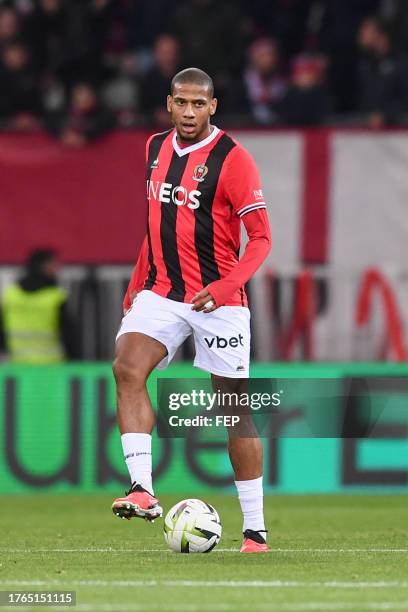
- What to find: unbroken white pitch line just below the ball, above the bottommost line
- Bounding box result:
[0,579,408,589]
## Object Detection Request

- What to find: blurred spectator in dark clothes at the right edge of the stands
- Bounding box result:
[358,17,408,128]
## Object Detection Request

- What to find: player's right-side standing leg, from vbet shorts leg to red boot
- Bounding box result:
[190,306,267,552]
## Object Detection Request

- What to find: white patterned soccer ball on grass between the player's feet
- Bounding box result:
[164,499,222,553]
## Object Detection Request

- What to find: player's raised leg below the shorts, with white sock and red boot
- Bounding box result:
[112,332,167,520]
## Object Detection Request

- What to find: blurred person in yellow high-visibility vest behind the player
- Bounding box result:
[0,249,76,364]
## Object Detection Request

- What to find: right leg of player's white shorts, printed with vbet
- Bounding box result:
[190,306,251,378]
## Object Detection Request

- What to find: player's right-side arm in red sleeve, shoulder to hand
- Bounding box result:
[192,146,272,312]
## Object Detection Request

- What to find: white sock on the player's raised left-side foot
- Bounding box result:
[122,433,153,493]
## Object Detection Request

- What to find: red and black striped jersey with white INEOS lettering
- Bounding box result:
[124,127,269,306]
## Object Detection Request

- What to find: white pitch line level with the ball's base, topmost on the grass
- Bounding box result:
[0,548,408,555]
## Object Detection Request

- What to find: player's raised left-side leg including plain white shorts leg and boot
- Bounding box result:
[112,291,191,520]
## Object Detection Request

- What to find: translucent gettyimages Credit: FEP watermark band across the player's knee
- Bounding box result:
[157,376,408,442]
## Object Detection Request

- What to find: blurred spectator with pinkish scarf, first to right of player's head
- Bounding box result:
[244,38,286,124]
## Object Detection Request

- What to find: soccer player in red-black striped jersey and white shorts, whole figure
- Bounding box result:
[112,68,271,552]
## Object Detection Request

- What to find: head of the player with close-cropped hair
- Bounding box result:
[167,68,217,142]
